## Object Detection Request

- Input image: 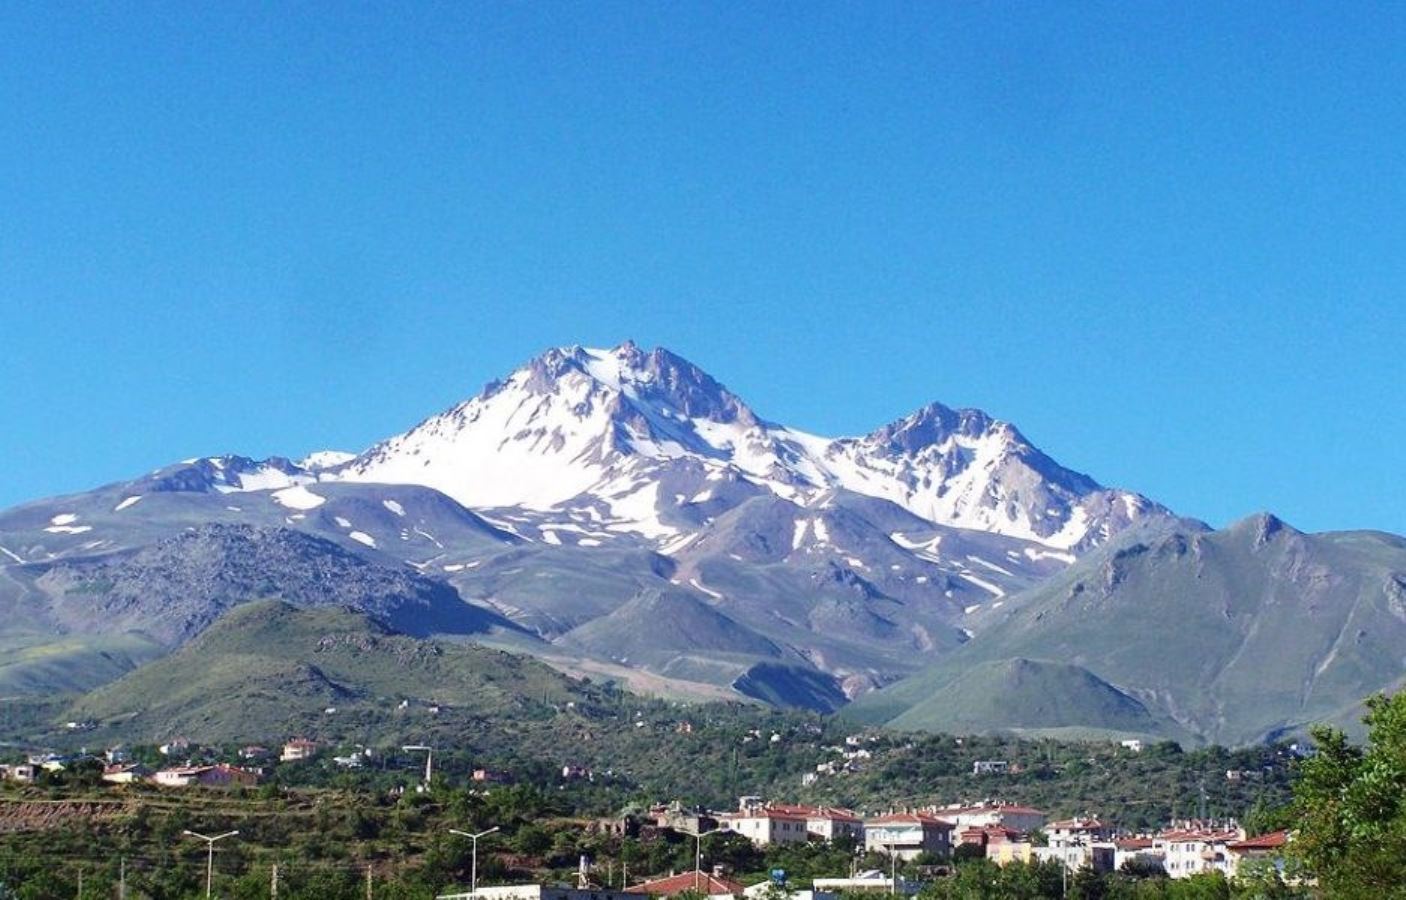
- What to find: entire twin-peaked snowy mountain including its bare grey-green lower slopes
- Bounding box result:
[0,337,1173,709]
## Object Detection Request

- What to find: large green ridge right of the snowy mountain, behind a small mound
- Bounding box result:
[853,515,1406,744]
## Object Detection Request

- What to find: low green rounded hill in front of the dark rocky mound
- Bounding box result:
[66,600,601,741]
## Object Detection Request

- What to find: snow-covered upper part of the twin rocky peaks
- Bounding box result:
[337,342,1168,551]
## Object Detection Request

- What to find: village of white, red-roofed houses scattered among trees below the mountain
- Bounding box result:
[0,737,1291,900]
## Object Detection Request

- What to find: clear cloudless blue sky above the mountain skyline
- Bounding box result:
[0,1,1406,532]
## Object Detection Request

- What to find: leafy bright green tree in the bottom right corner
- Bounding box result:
[1288,690,1406,900]
